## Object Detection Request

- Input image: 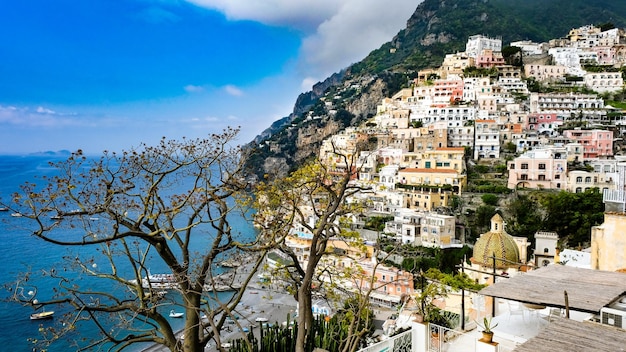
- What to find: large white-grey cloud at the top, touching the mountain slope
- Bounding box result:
[187,0,421,90]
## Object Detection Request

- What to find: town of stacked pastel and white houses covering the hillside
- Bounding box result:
[268,25,626,351]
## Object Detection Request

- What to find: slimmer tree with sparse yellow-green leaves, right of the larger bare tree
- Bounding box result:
[252,143,372,352]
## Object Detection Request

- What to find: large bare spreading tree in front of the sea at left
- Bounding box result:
[3,129,263,352]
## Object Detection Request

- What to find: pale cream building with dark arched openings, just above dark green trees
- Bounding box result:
[507,148,567,189]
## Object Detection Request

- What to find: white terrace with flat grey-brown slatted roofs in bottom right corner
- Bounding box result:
[360,265,626,352]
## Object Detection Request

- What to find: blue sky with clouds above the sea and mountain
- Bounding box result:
[0,0,421,154]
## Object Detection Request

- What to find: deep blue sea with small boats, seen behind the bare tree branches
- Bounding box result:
[0,155,256,352]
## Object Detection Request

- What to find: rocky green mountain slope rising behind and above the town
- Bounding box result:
[243,0,626,177]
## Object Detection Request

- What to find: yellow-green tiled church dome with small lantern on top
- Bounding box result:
[473,214,519,268]
